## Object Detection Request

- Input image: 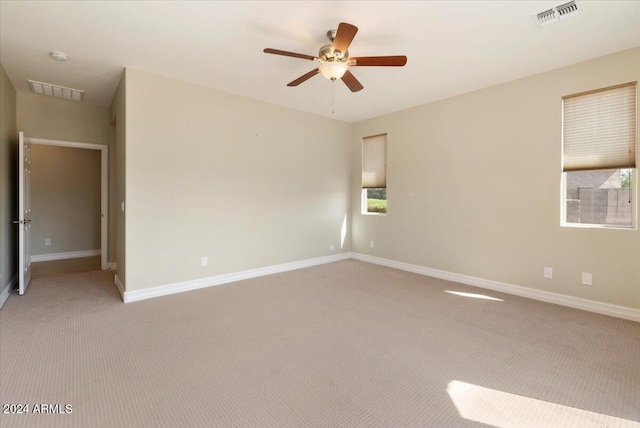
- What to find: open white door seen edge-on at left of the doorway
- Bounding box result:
[14,132,31,295]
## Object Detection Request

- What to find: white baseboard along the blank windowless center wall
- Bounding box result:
[122,253,351,303]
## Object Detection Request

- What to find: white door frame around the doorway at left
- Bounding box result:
[24,136,109,270]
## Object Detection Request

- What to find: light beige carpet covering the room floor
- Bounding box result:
[0,260,640,427]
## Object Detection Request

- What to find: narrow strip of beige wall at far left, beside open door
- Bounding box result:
[0,65,18,304]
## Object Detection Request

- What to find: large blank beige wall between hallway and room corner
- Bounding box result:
[124,69,351,291]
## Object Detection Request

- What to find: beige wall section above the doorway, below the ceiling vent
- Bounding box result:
[18,92,109,145]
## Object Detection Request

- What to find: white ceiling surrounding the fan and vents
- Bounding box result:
[0,0,640,122]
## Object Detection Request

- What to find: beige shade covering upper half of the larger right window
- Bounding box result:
[562,82,637,172]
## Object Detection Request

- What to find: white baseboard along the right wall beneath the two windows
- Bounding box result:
[351,253,640,322]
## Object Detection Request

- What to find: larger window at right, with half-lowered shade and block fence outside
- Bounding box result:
[562,82,637,227]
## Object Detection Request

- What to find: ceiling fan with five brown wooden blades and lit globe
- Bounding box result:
[264,22,407,92]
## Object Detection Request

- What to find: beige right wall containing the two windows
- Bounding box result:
[351,48,640,308]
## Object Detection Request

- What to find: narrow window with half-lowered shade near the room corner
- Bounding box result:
[362,134,387,215]
